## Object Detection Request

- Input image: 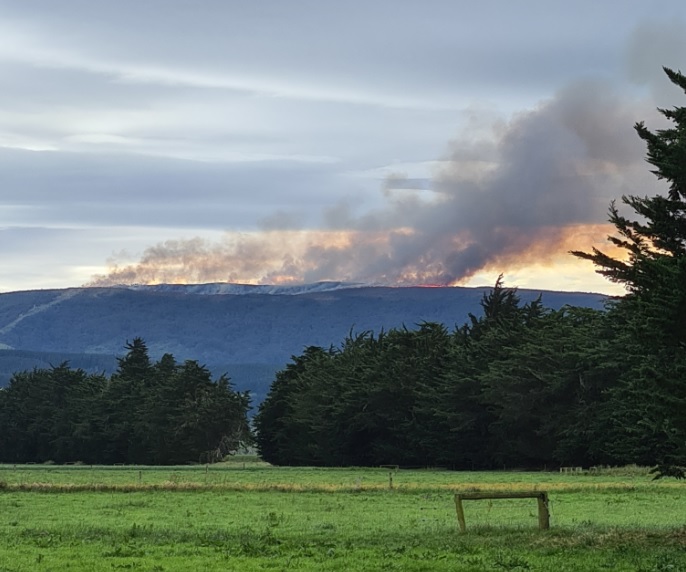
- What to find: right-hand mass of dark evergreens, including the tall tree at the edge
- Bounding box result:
[255,68,686,477]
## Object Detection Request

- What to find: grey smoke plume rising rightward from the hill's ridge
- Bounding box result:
[88,77,656,285]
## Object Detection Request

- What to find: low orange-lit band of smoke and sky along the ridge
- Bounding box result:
[93,224,623,293]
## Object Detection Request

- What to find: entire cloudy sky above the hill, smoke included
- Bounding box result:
[0,0,686,293]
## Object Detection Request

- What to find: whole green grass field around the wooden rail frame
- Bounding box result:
[0,458,686,572]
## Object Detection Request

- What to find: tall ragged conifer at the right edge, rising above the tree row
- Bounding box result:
[573,68,686,477]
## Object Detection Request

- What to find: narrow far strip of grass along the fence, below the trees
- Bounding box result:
[0,462,660,492]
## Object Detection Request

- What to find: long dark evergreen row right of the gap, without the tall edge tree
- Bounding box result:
[255,281,620,469]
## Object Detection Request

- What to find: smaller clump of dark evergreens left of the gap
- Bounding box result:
[0,338,251,465]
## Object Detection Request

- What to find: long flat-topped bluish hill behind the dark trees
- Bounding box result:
[0,282,606,401]
